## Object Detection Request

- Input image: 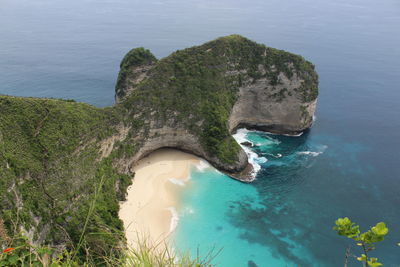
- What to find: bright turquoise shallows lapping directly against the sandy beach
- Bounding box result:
[174,166,288,266]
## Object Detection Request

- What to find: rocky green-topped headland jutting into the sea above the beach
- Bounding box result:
[116,35,318,178]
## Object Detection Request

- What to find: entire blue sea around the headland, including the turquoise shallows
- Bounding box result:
[0,0,400,267]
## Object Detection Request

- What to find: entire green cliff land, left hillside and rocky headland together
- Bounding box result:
[0,35,318,262]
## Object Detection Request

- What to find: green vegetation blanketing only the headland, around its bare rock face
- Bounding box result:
[117,35,318,163]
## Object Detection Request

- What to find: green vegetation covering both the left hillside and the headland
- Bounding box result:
[0,35,318,264]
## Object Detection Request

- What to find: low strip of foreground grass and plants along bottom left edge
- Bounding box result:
[0,236,220,267]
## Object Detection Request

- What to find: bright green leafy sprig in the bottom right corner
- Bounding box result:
[333,217,389,267]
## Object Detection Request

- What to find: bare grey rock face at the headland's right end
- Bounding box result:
[229,73,317,134]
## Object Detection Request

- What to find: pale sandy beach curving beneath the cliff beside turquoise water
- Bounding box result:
[119,149,200,248]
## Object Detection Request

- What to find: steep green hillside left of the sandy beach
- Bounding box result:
[0,96,131,262]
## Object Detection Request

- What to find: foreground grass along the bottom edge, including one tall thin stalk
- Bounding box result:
[0,171,220,267]
